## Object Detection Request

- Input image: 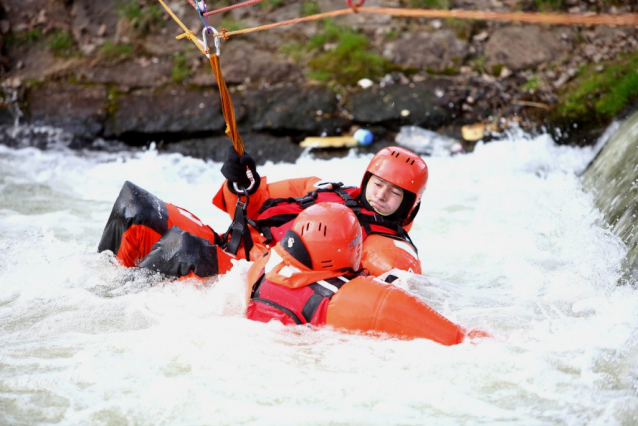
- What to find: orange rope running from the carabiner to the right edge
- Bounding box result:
[214,7,638,37]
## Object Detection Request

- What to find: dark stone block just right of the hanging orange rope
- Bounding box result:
[244,86,349,135]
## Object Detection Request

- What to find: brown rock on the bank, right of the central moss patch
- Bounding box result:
[383,30,468,72]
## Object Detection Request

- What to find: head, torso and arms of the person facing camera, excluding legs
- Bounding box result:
[213,146,428,275]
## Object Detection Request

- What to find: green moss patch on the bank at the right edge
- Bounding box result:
[556,52,638,121]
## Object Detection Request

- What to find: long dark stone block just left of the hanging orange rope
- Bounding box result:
[105,88,226,142]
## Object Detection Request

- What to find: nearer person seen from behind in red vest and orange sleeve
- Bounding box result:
[246,203,486,345]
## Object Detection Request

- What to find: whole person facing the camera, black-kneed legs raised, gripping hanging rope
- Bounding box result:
[98,147,428,277]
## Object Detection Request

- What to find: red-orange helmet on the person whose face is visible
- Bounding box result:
[361,146,428,222]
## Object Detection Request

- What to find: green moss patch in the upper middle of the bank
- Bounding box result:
[308,20,392,85]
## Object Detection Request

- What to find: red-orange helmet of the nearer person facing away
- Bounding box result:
[286,203,363,271]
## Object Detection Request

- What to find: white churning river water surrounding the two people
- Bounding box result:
[0,126,638,426]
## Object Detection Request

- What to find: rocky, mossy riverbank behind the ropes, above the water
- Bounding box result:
[0,0,638,159]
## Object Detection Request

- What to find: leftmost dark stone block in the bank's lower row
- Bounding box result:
[28,84,107,139]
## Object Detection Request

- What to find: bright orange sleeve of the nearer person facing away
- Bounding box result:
[326,277,465,346]
